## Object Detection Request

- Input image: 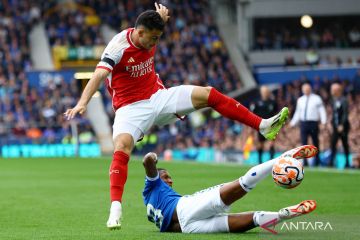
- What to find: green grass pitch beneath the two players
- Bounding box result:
[0,158,360,240]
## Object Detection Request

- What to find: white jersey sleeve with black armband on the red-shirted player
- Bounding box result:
[96,30,130,72]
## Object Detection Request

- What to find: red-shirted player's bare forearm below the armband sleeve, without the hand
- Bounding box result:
[78,69,109,106]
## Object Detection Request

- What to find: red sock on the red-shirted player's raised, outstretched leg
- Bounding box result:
[208,88,262,131]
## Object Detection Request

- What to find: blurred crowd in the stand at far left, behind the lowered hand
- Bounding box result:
[0,0,95,145]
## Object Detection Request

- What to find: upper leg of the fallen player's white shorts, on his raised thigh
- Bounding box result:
[176,185,229,227]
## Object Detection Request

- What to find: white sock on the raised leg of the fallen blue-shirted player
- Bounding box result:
[239,159,275,192]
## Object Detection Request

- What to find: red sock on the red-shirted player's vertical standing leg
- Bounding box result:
[109,151,129,202]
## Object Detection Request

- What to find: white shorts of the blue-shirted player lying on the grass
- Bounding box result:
[176,185,230,233]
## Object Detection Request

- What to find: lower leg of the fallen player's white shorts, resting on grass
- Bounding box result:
[181,215,229,233]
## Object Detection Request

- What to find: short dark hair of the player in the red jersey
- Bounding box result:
[135,10,165,31]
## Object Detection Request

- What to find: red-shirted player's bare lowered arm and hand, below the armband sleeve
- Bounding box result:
[64,68,109,120]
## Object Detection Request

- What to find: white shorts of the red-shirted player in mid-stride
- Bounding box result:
[113,85,195,143]
